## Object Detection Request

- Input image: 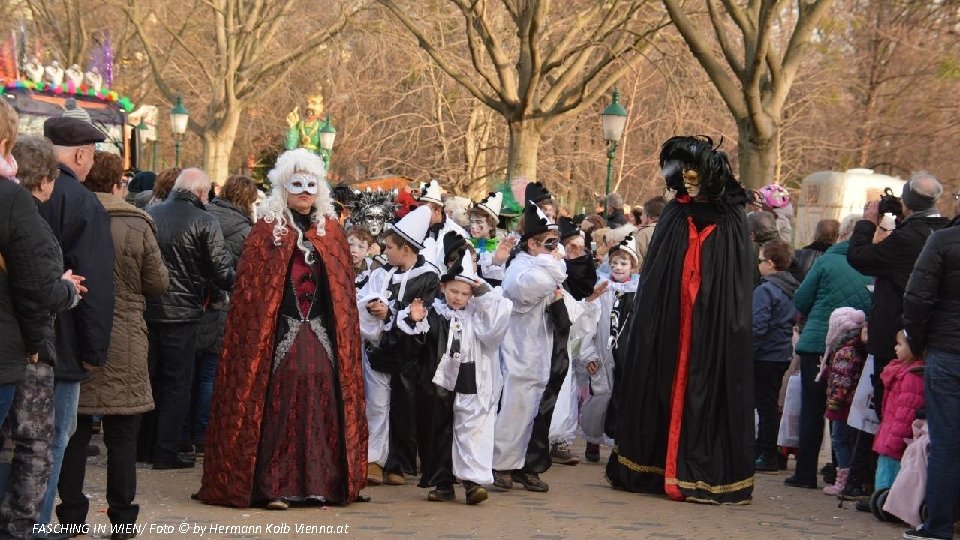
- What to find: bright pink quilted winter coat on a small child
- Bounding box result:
[873,359,923,461]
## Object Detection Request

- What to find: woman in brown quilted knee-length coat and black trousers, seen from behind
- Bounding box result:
[57,152,168,538]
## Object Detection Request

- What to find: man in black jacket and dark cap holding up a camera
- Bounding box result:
[847,173,950,408]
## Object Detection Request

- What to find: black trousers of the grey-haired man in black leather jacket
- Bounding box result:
[140,322,199,463]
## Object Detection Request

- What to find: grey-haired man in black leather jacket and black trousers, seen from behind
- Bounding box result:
[140,169,234,469]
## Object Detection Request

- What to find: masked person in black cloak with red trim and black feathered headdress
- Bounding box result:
[607,136,756,504]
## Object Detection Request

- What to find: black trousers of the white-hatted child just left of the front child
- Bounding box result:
[383,365,418,475]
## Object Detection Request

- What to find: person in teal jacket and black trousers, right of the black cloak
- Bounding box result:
[784,216,871,488]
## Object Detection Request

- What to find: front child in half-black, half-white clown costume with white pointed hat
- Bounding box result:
[401,250,513,504]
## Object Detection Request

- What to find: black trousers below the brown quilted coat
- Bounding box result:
[57,414,140,525]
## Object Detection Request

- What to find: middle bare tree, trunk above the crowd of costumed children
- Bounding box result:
[380,0,665,184]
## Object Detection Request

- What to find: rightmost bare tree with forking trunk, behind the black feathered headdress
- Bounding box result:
[663,0,832,187]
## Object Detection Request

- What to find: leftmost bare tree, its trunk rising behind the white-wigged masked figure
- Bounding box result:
[124,0,364,182]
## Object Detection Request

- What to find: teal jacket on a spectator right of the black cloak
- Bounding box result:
[793,241,872,354]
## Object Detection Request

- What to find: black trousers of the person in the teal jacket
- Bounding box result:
[794,353,827,484]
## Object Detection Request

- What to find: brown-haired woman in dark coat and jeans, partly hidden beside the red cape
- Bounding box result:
[180,175,257,456]
